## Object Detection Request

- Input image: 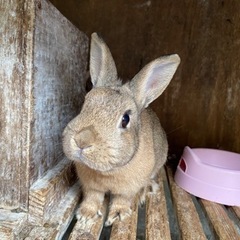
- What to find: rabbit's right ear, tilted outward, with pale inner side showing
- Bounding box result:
[129,54,180,108]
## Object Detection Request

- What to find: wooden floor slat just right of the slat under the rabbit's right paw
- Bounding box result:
[146,168,171,240]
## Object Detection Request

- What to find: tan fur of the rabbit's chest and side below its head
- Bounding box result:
[76,110,166,196]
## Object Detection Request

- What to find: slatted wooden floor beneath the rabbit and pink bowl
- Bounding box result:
[64,167,240,240]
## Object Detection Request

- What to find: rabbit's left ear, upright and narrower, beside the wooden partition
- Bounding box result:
[90,33,118,87]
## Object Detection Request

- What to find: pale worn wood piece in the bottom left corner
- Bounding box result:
[0,209,27,240]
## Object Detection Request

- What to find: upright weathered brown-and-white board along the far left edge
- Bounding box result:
[0,0,34,209]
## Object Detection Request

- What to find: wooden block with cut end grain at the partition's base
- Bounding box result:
[29,158,75,224]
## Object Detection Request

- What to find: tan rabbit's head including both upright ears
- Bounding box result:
[63,33,180,172]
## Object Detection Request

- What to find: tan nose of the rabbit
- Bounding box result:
[75,128,96,149]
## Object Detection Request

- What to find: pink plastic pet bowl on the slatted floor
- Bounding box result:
[174,147,240,206]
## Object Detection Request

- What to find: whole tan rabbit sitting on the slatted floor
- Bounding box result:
[63,33,180,226]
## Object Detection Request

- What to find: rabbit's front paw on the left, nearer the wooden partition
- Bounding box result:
[76,203,103,224]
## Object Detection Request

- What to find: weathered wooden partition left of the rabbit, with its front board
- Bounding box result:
[0,0,88,210]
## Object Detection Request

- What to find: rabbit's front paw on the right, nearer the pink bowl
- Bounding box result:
[105,205,132,226]
